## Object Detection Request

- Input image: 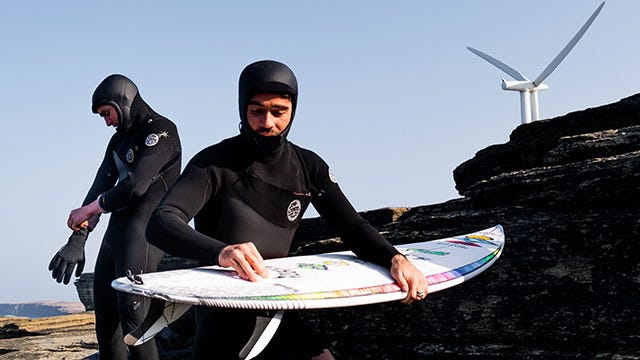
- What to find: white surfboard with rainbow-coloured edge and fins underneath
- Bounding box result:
[111,225,505,358]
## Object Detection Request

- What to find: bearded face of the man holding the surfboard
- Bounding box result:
[247,94,292,136]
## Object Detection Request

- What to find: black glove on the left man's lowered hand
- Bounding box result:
[49,227,89,285]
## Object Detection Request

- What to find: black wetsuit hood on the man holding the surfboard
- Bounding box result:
[238,60,298,155]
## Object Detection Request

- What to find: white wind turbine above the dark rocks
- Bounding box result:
[467,1,605,124]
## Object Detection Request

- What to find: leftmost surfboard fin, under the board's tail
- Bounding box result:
[124,299,191,346]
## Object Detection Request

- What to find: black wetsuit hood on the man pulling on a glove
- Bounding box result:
[91,74,155,132]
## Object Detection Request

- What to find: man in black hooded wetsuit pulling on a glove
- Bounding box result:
[49,75,181,359]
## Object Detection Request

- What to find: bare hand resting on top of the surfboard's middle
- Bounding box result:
[218,242,269,281]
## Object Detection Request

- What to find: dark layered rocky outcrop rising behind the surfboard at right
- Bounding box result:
[70,95,640,359]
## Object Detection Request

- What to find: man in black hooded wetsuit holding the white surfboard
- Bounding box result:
[147,61,427,359]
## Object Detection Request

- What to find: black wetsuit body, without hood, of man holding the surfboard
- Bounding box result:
[147,135,397,359]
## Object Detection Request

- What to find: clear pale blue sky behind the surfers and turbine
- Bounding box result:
[0,0,640,303]
